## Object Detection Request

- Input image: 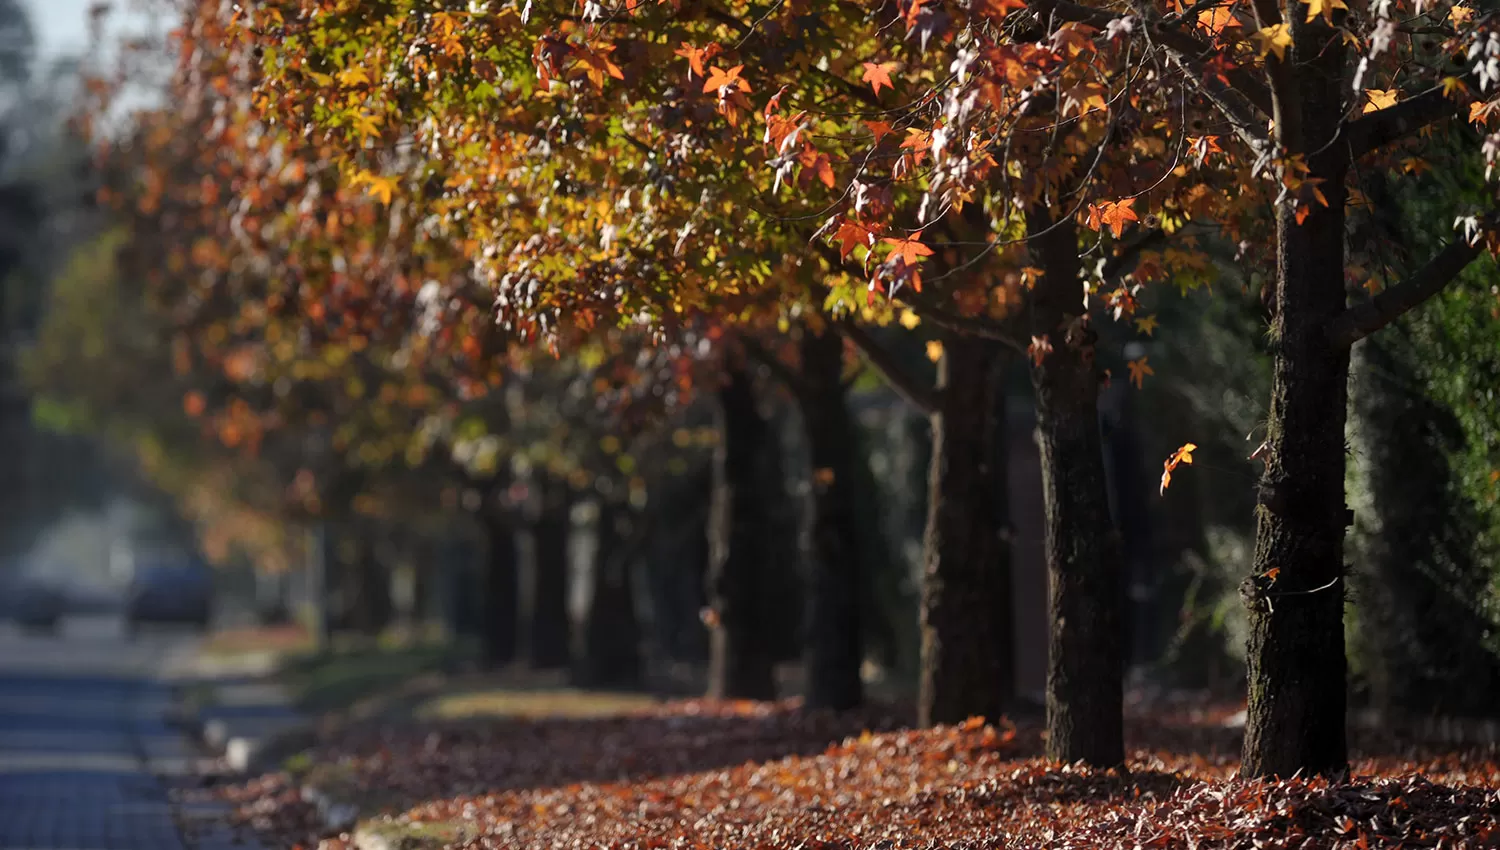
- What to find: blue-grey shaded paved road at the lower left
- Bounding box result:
[0,618,258,850]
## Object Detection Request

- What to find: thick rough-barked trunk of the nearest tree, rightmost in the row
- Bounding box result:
[1241,28,1350,777]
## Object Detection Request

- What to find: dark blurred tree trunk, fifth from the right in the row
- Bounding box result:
[708,358,776,700]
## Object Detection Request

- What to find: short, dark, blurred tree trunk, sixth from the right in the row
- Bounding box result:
[579,502,642,688]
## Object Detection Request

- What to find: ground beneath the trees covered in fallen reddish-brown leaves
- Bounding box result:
[208,702,1500,850]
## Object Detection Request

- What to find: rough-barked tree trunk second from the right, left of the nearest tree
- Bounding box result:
[1028,210,1125,766]
